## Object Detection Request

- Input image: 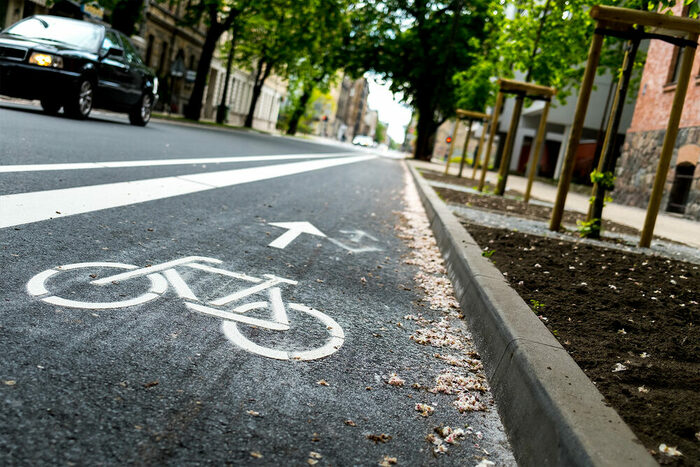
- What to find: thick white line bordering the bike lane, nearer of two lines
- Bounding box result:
[0,156,376,228]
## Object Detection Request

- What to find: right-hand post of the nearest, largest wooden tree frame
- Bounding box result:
[639,34,698,248]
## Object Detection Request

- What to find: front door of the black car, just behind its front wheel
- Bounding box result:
[97,30,130,107]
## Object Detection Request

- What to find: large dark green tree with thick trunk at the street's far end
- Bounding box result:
[350,0,491,159]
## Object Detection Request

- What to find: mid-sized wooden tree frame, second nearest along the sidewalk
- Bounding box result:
[478,78,557,194]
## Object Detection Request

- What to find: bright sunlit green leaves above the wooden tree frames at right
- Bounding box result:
[452,0,698,110]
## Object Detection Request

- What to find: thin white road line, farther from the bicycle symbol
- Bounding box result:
[0,152,357,173]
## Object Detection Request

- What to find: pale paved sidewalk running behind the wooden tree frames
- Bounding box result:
[415,161,700,248]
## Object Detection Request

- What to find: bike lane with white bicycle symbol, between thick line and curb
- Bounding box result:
[0,155,513,465]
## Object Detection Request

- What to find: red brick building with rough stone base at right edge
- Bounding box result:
[612,5,700,220]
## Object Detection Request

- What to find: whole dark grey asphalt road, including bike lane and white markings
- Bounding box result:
[0,103,513,465]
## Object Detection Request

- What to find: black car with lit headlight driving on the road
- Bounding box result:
[0,15,158,126]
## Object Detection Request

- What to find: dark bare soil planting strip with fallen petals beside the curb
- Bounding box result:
[423,172,700,466]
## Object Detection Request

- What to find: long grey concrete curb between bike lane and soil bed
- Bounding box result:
[408,163,658,467]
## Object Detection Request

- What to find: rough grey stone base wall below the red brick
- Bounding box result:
[611,126,700,220]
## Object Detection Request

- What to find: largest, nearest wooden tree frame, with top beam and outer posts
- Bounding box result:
[549,5,700,247]
